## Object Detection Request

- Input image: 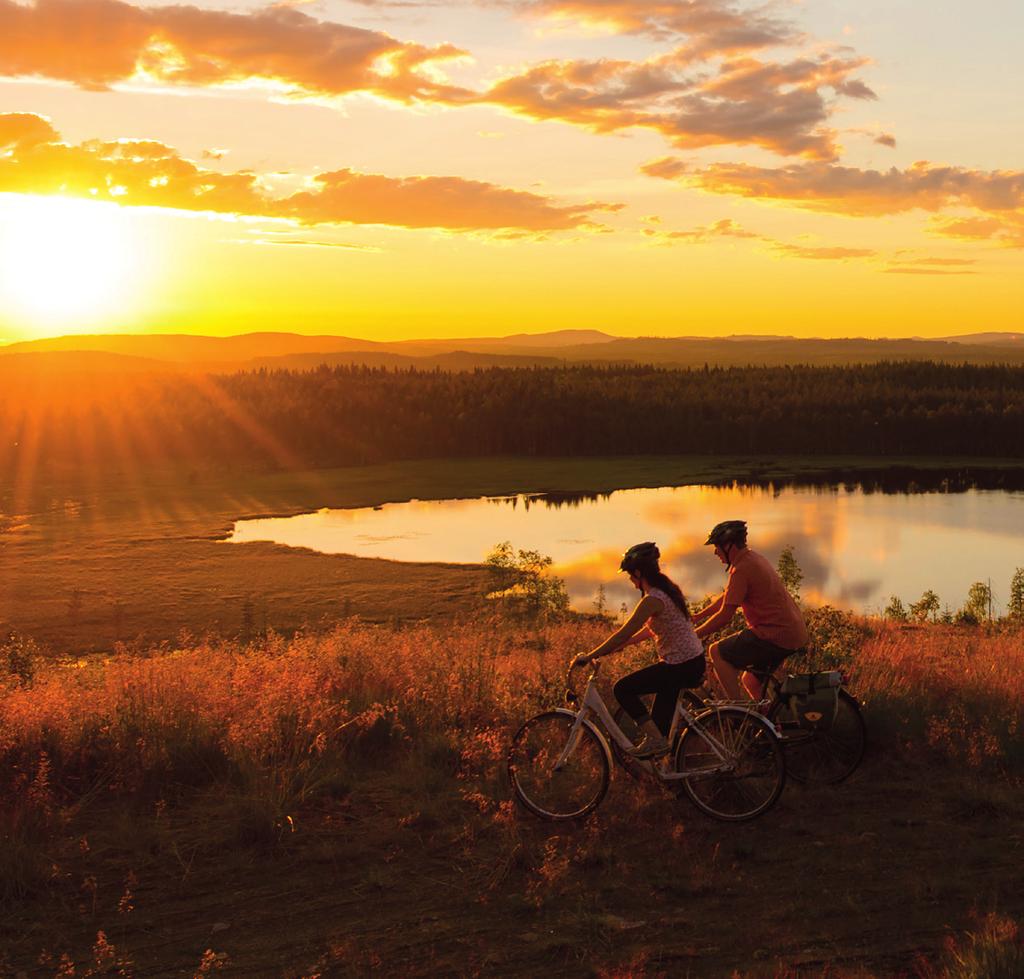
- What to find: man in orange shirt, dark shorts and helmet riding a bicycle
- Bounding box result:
[693,520,807,700]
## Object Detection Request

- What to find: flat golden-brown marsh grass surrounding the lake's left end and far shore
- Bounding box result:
[0,457,1019,652]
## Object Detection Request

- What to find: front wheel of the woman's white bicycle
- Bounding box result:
[508,711,611,820]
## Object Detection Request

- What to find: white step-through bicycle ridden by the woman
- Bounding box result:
[508,659,785,822]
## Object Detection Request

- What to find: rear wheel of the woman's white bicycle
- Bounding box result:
[676,707,785,822]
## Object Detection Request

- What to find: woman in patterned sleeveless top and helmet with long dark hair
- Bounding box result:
[575,541,705,758]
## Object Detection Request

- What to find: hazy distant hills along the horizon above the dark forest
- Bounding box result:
[6,330,1024,373]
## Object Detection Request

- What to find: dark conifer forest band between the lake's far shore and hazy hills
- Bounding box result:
[0,363,1024,476]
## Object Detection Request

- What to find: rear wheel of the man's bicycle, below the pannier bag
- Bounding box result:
[768,690,867,785]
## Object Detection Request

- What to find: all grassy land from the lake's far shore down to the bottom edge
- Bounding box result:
[6,448,1024,979]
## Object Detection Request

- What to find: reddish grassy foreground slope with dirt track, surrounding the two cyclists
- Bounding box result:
[0,615,1024,979]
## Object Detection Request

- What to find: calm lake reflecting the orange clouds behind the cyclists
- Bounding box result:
[229,486,1024,611]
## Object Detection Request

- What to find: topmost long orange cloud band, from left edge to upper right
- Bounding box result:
[0,0,874,160]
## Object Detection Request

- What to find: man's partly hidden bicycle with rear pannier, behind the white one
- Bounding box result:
[684,670,867,784]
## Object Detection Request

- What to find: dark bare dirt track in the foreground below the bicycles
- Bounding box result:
[0,757,1024,979]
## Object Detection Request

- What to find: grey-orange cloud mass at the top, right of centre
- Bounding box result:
[473,0,876,160]
